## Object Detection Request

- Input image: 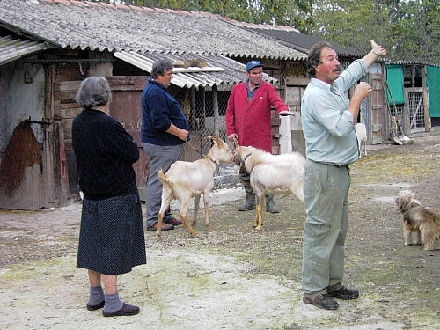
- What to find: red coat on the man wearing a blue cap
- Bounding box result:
[225,81,289,153]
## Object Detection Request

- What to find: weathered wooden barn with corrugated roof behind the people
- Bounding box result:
[4,0,436,209]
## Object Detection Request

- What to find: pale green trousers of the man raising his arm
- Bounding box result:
[302,160,350,296]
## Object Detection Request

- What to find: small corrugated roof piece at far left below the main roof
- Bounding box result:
[0,36,48,65]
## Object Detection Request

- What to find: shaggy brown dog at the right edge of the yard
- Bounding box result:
[396,190,440,251]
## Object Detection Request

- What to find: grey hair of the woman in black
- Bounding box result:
[75,77,112,108]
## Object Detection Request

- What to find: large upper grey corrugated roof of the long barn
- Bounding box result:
[0,0,306,60]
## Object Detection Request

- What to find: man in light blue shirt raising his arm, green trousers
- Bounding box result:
[301,40,386,310]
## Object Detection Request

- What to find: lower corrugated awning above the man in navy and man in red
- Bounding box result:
[114,51,276,87]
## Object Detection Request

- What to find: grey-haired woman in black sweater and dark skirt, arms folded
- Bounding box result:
[72,77,146,317]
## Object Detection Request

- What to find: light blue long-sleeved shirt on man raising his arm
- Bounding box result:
[301,60,367,165]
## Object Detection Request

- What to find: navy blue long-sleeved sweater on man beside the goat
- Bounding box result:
[141,79,188,146]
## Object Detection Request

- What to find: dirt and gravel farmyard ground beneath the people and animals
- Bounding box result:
[0,132,440,330]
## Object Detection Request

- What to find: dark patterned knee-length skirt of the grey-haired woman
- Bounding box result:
[77,194,146,275]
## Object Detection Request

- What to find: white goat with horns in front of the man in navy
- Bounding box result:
[157,136,234,240]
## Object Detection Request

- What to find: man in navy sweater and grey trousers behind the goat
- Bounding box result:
[141,60,189,231]
